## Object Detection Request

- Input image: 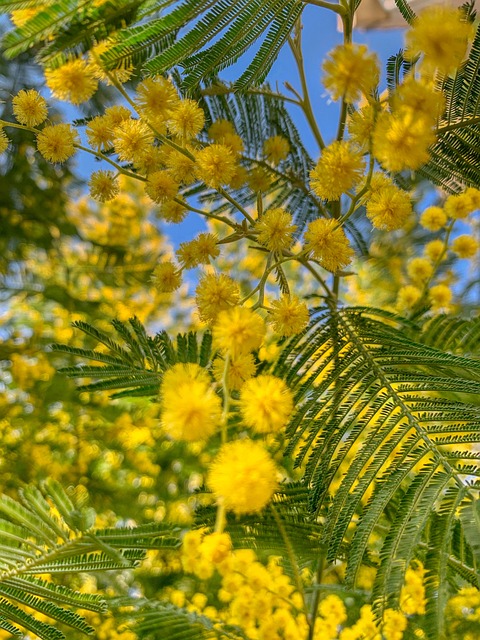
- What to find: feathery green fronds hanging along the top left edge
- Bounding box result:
[1,0,304,90]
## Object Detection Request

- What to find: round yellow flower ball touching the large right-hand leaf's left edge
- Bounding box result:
[239,375,293,433]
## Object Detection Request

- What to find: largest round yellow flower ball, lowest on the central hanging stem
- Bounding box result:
[207,440,278,515]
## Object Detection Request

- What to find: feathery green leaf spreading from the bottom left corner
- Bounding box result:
[0,480,178,640]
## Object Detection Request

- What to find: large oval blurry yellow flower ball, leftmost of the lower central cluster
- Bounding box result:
[160,363,221,442]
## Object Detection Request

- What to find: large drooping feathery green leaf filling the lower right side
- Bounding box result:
[276,309,480,609]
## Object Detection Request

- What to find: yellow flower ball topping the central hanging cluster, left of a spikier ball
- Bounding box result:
[212,307,265,359]
